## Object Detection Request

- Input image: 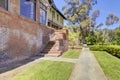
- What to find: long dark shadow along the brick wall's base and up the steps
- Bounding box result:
[0,41,55,74]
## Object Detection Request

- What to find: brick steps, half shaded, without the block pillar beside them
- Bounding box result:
[41,41,61,57]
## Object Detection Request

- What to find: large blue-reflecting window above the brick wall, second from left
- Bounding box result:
[20,0,36,20]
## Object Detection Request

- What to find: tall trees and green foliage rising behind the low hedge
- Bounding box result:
[63,0,120,45]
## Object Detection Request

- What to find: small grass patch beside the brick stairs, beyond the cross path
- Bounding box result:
[62,50,80,58]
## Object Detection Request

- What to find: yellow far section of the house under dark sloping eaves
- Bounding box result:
[47,0,66,29]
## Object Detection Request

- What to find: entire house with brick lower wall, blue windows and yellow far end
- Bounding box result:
[0,0,68,64]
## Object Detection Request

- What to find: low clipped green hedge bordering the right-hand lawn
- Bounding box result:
[89,45,120,58]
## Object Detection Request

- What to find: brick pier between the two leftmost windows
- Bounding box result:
[8,0,20,15]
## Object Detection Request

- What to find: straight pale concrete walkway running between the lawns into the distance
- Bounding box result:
[69,48,107,80]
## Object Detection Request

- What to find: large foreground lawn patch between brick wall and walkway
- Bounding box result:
[12,61,73,80]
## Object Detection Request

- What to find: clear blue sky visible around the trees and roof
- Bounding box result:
[54,0,120,28]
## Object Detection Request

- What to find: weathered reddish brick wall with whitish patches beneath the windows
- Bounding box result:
[0,0,54,63]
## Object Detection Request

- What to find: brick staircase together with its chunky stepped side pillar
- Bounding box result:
[39,30,68,57]
